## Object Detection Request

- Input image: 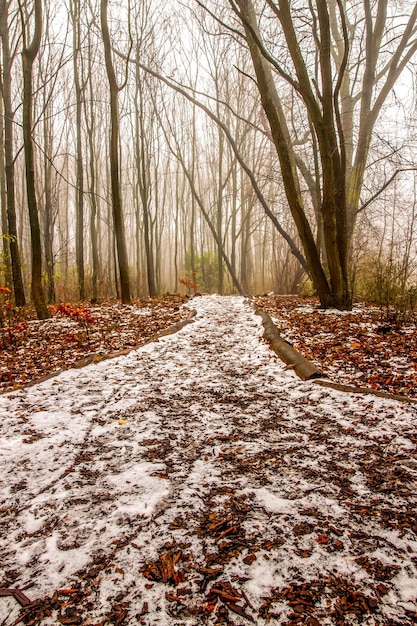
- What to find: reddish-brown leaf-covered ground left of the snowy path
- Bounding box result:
[0,295,185,392]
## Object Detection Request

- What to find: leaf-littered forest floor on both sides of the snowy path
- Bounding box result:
[0,296,417,398]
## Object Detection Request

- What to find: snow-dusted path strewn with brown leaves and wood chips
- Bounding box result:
[0,296,417,626]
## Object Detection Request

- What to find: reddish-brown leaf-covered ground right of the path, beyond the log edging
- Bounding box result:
[256,296,417,398]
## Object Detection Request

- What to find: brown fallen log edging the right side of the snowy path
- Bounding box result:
[255,307,323,380]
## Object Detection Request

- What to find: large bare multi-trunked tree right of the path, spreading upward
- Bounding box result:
[223,0,417,309]
